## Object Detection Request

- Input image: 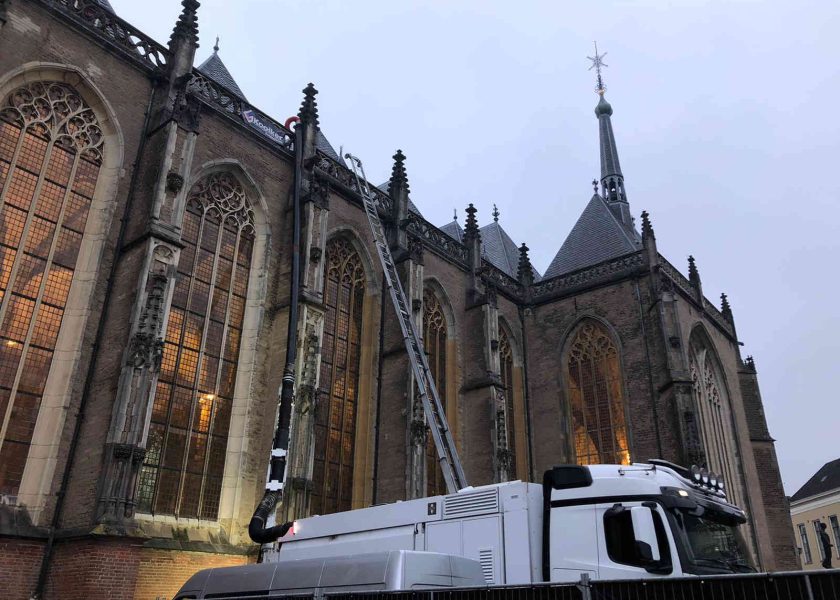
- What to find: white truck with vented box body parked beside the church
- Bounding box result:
[267,461,753,585]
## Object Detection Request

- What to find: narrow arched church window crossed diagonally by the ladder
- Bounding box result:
[423,289,447,496]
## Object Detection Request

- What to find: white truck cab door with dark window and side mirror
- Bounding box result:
[596,502,682,579]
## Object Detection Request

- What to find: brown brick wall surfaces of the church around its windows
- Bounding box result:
[0,0,797,599]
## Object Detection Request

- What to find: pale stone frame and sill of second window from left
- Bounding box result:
[135,158,276,544]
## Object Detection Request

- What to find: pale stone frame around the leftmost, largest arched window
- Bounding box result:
[0,61,125,524]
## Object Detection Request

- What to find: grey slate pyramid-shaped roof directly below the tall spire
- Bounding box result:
[543,194,642,279]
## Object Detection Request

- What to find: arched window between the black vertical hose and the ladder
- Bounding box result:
[310,238,365,514]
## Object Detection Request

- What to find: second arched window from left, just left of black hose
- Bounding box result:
[138,172,254,519]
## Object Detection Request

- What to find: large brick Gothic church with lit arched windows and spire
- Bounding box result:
[0,0,797,598]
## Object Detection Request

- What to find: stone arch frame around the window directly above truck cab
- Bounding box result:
[560,312,633,462]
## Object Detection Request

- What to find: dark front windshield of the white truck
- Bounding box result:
[673,510,755,573]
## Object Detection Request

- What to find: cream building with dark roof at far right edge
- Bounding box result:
[790,458,840,570]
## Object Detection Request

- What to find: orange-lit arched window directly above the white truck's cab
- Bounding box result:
[566,319,630,465]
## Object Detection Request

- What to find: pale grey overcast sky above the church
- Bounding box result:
[111,0,840,494]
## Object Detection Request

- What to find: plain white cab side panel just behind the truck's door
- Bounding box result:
[549,504,598,581]
